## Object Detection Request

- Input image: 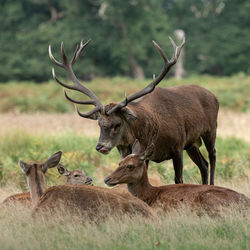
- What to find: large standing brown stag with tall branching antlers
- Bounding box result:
[49,37,219,185]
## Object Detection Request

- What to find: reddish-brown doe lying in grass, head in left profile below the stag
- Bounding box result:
[104,140,250,215]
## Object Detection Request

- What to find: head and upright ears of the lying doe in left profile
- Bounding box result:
[104,140,154,186]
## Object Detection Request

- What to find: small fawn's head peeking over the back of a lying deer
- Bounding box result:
[57,164,92,185]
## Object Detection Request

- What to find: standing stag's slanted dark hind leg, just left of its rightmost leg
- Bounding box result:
[187,146,208,185]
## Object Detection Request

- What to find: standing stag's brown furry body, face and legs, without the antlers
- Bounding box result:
[98,85,219,184]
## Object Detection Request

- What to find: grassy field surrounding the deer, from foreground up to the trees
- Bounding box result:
[0,75,250,250]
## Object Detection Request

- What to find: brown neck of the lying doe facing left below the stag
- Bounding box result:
[127,165,158,205]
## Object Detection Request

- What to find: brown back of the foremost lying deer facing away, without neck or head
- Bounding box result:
[33,185,154,219]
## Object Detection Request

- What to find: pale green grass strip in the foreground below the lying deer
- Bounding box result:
[0,207,250,250]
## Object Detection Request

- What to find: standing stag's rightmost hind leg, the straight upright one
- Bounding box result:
[202,133,216,185]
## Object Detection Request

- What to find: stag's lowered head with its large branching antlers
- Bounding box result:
[49,37,185,154]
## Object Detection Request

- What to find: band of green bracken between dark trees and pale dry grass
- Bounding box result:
[0,75,250,113]
